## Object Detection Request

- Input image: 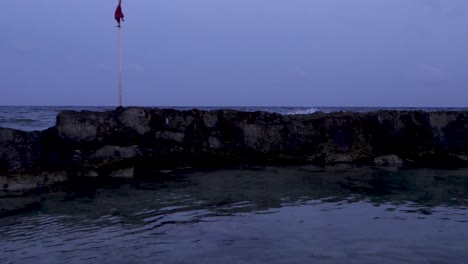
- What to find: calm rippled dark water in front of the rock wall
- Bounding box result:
[0,166,468,264]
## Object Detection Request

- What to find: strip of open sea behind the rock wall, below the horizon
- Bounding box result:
[0,106,468,131]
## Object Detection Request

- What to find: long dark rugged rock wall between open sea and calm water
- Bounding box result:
[0,108,468,189]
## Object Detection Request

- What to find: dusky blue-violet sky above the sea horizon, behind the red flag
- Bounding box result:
[0,0,468,107]
